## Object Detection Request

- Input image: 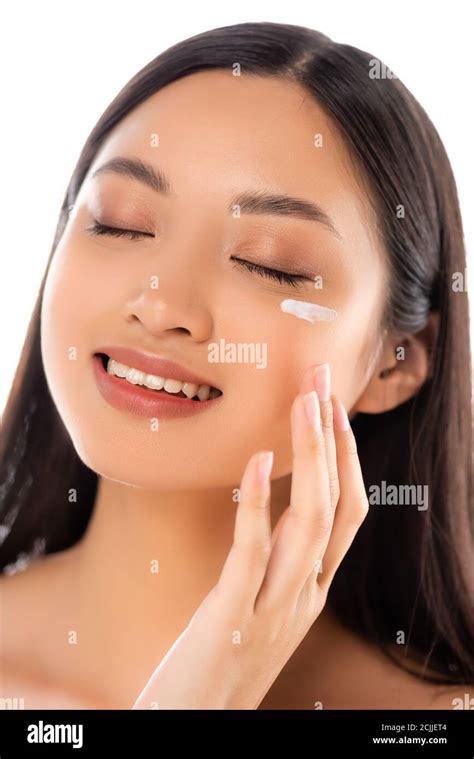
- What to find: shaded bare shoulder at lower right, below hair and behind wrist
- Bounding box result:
[260,612,474,710]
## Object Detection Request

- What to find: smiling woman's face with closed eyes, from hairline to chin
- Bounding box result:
[41,71,386,489]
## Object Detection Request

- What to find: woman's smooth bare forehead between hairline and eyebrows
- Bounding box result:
[88,70,380,252]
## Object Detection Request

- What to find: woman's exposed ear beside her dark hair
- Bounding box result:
[352,311,439,414]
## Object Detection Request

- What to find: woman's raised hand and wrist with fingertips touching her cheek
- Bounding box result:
[133,366,368,709]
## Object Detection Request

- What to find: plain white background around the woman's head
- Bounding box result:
[0,0,474,410]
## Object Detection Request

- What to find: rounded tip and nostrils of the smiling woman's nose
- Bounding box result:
[125,273,213,342]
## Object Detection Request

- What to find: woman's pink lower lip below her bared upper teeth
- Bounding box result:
[92,355,223,418]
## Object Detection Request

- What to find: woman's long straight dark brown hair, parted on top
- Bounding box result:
[0,23,474,683]
